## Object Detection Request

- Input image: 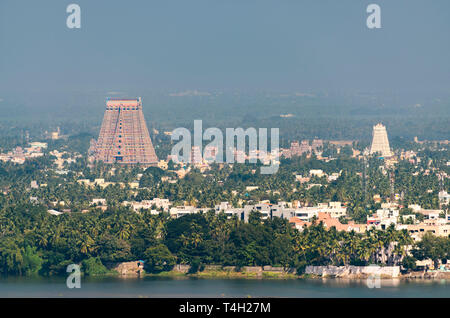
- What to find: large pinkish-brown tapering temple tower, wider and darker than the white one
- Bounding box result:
[94,98,158,166]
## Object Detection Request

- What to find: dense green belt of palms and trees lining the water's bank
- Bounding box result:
[0,205,436,275]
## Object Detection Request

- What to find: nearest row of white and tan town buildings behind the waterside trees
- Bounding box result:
[58,193,450,240]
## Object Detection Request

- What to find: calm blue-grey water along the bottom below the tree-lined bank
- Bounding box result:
[0,277,450,297]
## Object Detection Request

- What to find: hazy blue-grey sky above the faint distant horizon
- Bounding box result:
[0,0,450,94]
